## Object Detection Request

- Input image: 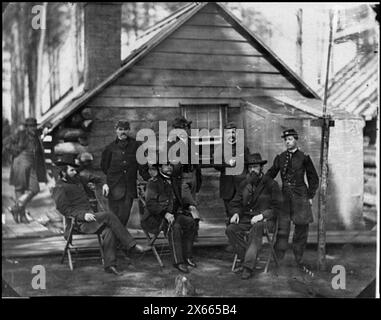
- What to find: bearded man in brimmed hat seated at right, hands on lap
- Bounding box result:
[226,153,282,279]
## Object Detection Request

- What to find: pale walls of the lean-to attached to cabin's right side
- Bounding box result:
[245,102,364,230]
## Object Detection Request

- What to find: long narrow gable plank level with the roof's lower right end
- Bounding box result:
[99,85,296,99]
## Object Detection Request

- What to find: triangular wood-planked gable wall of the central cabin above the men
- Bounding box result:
[89,6,302,108]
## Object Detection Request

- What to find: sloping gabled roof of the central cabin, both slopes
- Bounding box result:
[39,2,320,129]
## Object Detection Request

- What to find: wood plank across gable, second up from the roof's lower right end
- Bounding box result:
[115,66,294,88]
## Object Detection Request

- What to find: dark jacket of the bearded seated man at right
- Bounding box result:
[230,175,282,223]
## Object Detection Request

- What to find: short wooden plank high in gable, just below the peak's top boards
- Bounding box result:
[170,26,247,42]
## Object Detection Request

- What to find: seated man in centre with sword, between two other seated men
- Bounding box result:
[141,163,196,273]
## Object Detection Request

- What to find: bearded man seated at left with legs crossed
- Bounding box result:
[52,156,150,275]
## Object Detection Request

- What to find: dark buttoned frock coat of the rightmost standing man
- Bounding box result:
[266,149,319,224]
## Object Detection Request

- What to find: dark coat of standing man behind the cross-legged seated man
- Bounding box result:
[101,137,150,200]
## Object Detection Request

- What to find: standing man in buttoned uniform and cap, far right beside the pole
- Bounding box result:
[266,129,319,268]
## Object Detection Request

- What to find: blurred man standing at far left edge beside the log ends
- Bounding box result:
[3,118,47,223]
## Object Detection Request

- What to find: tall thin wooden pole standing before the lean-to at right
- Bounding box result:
[317,10,335,271]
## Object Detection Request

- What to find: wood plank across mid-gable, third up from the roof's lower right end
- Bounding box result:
[136,52,279,73]
